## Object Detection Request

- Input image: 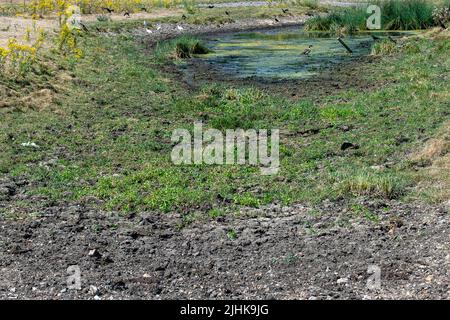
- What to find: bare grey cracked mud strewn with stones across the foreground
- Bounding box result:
[0,192,450,299]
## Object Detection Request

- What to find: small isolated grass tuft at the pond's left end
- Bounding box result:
[155,36,211,61]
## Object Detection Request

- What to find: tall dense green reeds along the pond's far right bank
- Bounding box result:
[306,0,437,34]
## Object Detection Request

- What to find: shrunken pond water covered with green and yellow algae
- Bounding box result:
[193,27,414,80]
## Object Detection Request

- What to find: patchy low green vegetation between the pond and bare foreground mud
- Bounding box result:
[0,22,450,215]
